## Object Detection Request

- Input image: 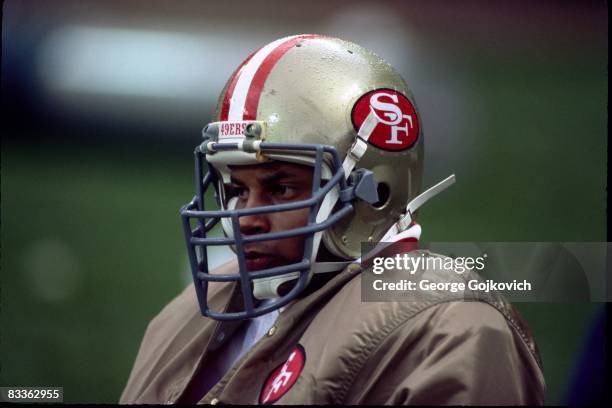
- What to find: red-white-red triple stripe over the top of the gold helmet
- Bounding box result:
[220,34,321,121]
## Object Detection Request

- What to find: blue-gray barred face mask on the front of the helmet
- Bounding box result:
[180,140,358,320]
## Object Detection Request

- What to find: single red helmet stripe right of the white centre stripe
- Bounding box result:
[243,34,322,120]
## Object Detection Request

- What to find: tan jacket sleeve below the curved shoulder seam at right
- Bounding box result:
[344,301,545,405]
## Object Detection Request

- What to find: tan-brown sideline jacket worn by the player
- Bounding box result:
[120,254,545,405]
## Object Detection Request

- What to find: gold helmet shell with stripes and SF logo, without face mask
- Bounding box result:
[213,35,423,259]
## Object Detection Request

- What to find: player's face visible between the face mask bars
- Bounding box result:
[231,162,313,271]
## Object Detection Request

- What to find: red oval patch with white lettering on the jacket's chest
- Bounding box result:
[259,344,306,405]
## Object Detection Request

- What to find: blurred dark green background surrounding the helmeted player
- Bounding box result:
[0,1,608,404]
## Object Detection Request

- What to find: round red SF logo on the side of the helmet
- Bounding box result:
[351,89,419,151]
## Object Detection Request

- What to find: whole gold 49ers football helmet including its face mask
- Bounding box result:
[181,35,432,320]
